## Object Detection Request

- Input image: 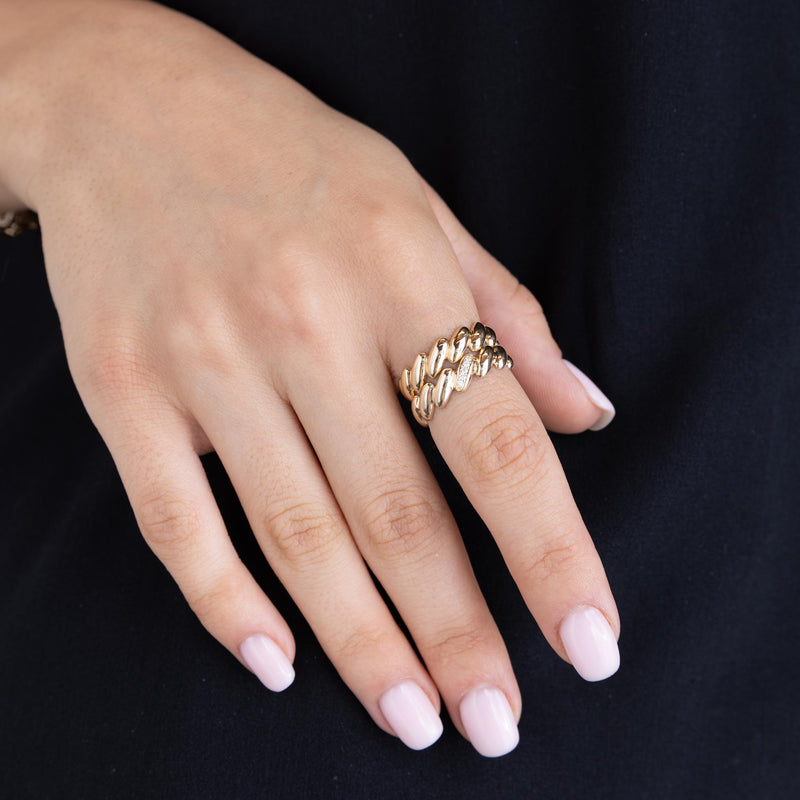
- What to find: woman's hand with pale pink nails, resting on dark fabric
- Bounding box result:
[0,1,619,755]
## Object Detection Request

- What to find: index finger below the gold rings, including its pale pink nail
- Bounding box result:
[401,322,619,681]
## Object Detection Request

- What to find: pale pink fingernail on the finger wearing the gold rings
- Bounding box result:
[559,606,619,681]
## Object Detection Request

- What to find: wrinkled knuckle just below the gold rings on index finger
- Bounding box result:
[466,405,547,491]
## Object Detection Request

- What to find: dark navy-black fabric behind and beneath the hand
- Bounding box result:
[0,0,800,800]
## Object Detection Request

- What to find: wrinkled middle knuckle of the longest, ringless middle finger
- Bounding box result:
[366,487,441,562]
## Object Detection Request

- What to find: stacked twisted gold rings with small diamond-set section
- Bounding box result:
[400,322,514,427]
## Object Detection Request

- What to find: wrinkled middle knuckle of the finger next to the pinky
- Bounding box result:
[265,503,344,568]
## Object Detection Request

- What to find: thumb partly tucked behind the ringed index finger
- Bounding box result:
[424,183,614,433]
